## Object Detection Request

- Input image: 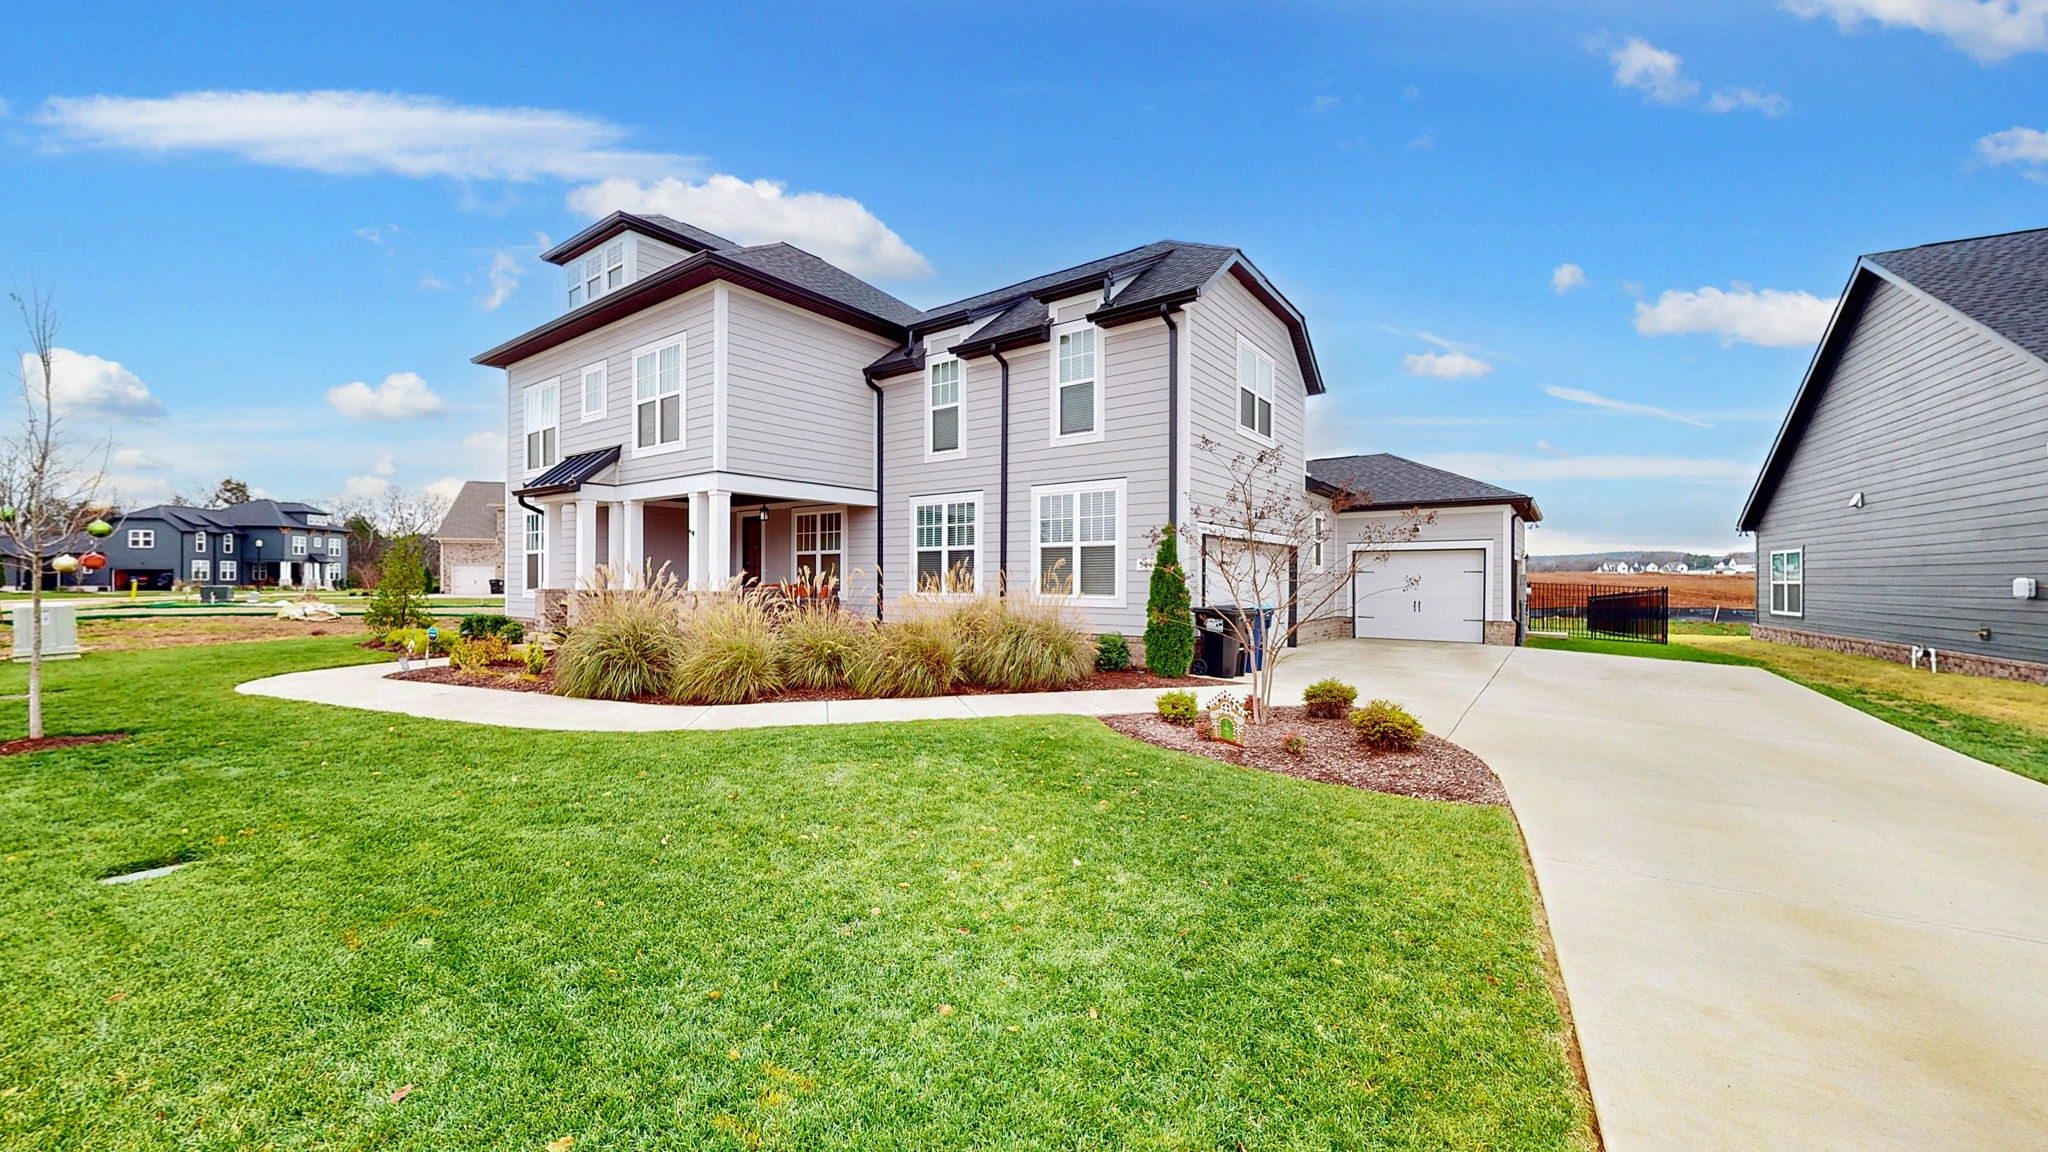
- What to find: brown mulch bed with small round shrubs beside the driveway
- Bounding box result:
[1102,707,1507,806]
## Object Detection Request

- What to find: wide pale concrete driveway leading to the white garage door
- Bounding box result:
[1280,642,2048,1152]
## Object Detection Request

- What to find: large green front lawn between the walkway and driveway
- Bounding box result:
[0,637,1589,1152]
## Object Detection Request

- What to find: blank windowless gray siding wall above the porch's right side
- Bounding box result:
[725,287,891,488]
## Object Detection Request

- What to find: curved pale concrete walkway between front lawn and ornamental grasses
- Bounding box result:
[236,660,1208,732]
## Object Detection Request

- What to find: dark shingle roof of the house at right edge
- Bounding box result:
[1864,228,2048,359]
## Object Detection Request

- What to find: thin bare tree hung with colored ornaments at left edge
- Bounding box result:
[0,283,111,740]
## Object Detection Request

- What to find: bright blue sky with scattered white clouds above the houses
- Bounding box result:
[0,0,2048,551]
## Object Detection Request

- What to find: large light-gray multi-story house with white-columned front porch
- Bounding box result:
[477,213,1540,637]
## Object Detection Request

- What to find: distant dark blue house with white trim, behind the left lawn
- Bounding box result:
[100,500,348,590]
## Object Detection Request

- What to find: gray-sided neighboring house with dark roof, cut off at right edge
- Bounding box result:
[1739,230,2048,681]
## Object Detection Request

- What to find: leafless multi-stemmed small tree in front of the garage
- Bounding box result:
[1180,437,1436,722]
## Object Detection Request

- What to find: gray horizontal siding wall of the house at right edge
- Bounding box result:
[1757,272,2048,660]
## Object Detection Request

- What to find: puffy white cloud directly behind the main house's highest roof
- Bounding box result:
[569,176,932,279]
